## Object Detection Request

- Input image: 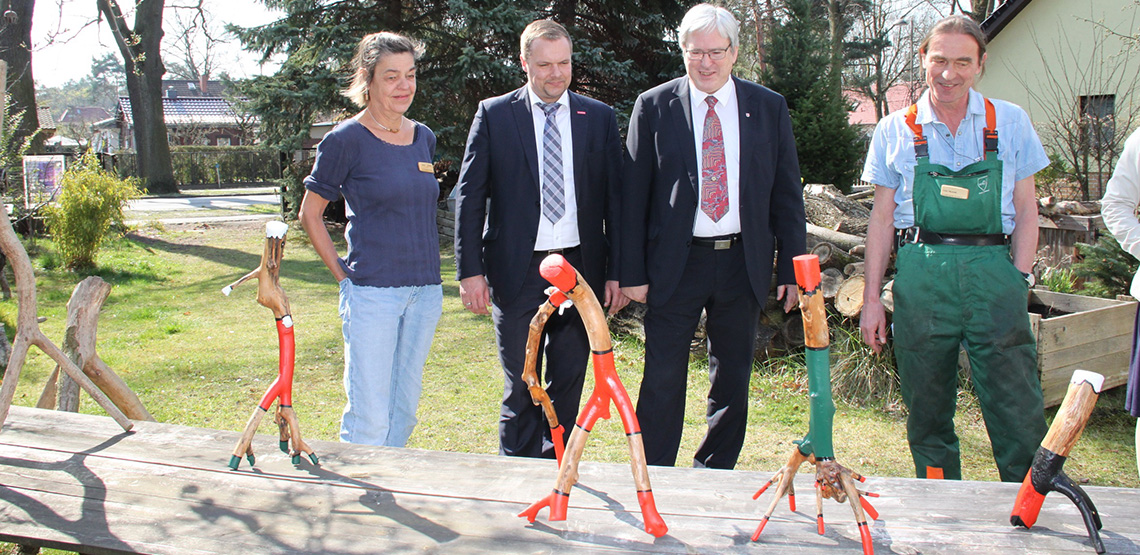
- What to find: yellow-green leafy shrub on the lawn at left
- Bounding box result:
[46,152,141,269]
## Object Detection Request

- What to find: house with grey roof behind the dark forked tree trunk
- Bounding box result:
[96,80,258,152]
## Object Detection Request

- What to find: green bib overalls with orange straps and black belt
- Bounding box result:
[894,100,1047,482]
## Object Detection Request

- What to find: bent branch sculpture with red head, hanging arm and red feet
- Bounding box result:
[519,254,669,538]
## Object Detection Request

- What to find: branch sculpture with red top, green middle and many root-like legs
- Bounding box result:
[752,254,879,555]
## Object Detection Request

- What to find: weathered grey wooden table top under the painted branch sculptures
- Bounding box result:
[0,407,1140,555]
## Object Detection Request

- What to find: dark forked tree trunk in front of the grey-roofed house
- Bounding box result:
[97,0,178,194]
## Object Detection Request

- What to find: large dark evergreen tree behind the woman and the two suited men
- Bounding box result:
[235,0,684,164]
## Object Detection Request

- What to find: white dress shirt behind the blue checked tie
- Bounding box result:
[527,85,579,251]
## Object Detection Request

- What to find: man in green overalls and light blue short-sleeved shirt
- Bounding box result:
[860,16,1049,482]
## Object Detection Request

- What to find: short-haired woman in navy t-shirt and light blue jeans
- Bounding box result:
[300,32,443,447]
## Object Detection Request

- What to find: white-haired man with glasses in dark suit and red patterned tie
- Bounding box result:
[620,5,806,468]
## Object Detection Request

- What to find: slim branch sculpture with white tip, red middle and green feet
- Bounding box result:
[221,221,318,470]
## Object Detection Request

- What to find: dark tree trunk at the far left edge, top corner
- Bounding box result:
[0,0,43,154]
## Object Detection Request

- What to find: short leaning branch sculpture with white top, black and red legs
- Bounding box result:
[1009,370,1105,553]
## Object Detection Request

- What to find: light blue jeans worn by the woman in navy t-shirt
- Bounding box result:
[340,278,443,447]
